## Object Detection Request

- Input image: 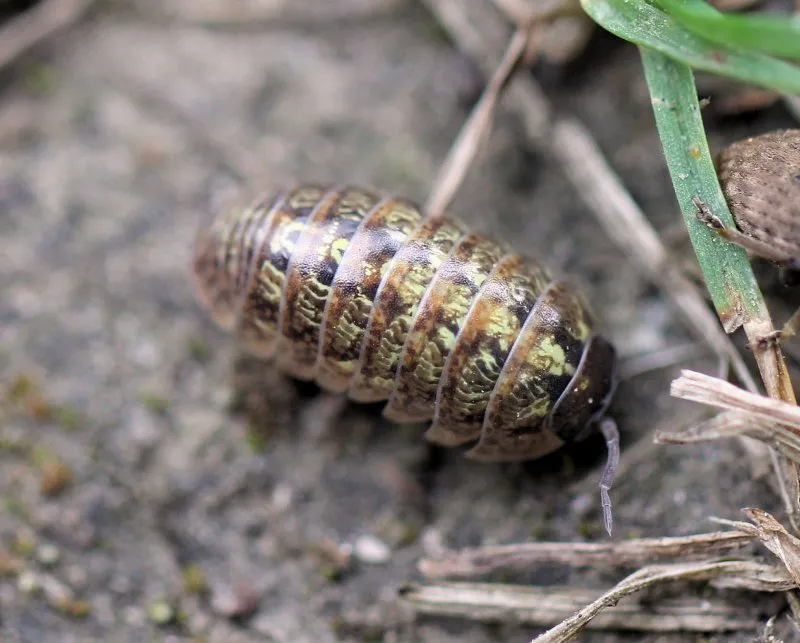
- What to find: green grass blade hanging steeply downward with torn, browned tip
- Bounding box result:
[641,48,765,332]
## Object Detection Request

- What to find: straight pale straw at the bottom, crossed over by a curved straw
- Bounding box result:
[401,583,759,640]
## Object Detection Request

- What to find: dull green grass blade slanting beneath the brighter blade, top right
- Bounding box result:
[581,0,800,96]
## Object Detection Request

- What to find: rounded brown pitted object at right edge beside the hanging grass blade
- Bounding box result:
[719,129,800,260]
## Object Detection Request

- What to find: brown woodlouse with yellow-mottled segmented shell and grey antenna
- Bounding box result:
[193,185,619,531]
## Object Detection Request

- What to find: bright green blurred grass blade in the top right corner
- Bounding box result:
[653,0,800,59]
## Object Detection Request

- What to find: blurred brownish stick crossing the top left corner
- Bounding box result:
[0,0,94,69]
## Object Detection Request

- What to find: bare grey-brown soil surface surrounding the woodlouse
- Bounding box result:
[0,0,791,643]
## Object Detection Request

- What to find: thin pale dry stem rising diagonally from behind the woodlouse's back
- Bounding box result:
[423,27,540,217]
